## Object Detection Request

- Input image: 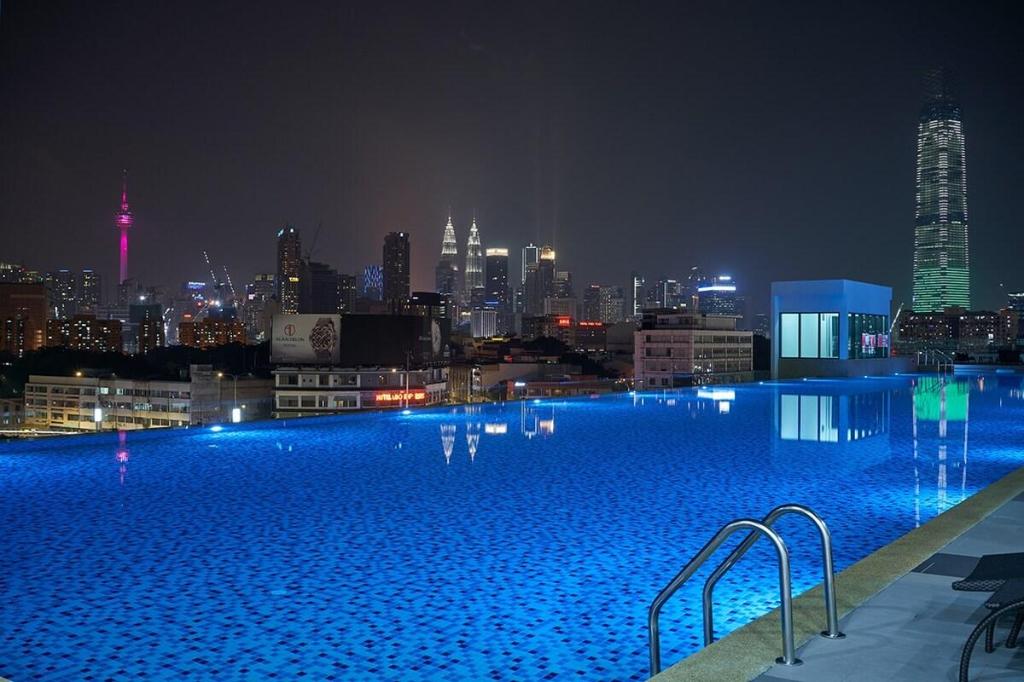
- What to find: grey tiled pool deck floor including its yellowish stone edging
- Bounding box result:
[653,468,1024,682]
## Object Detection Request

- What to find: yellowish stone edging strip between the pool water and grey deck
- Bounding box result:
[652,467,1024,682]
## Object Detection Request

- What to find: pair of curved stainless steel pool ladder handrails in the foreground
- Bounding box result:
[647,504,846,677]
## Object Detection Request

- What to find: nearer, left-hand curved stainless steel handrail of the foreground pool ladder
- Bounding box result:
[647,518,801,677]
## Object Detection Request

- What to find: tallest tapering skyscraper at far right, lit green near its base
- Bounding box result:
[912,70,971,312]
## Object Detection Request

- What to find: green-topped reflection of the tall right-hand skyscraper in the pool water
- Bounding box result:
[912,377,971,518]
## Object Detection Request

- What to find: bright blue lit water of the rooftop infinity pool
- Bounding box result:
[0,375,1024,682]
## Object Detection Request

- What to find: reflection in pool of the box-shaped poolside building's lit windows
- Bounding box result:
[775,391,891,443]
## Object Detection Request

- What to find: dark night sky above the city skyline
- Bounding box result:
[0,0,1024,309]
